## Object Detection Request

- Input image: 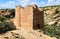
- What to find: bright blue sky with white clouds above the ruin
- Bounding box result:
[0,0,60,8]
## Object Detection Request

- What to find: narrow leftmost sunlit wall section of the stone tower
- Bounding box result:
[13,6,22,29]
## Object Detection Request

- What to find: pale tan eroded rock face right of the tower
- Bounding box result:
[44,7,60,26]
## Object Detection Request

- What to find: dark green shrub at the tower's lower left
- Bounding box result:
[0,22,15,33]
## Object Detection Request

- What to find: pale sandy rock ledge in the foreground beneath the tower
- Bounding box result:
[0,29,56,39]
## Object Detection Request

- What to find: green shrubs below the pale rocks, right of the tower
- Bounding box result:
[44,25,60,39]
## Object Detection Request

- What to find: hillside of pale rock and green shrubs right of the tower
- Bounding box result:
[39,5,60,39]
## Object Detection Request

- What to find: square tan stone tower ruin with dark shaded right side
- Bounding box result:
[14,4,44,29]
